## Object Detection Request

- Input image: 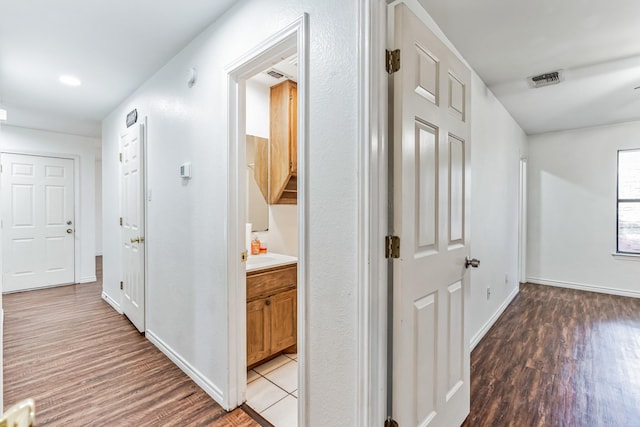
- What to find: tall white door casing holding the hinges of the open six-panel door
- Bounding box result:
[355,0,388,426]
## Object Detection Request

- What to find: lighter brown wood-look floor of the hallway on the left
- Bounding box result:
[3,258,259,427]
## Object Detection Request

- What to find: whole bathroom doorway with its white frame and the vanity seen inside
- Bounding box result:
[228,15,308,426]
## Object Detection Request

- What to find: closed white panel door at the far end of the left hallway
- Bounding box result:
[0,154,75,292]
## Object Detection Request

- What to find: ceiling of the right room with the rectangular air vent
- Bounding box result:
[419,0,640,134]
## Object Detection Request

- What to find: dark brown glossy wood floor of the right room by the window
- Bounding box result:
[463,284,640,426]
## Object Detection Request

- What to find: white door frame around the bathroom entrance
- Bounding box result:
[223,13,309,418]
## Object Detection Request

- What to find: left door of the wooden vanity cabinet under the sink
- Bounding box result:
[247,298,271,366]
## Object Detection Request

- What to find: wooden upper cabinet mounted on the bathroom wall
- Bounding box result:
[269,80,298,204]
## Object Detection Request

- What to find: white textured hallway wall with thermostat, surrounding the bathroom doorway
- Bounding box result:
[102,0,358,426]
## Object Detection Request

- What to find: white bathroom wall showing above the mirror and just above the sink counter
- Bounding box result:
[247,78,298,256]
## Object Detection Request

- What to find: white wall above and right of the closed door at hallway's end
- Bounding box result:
[0,125,96,283]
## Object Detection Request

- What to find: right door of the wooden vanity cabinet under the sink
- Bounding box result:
[269,289,298,353]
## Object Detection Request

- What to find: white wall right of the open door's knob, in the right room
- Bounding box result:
[470,73,527,347]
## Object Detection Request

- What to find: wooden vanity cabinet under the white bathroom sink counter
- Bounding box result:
[247,264,298,367]
